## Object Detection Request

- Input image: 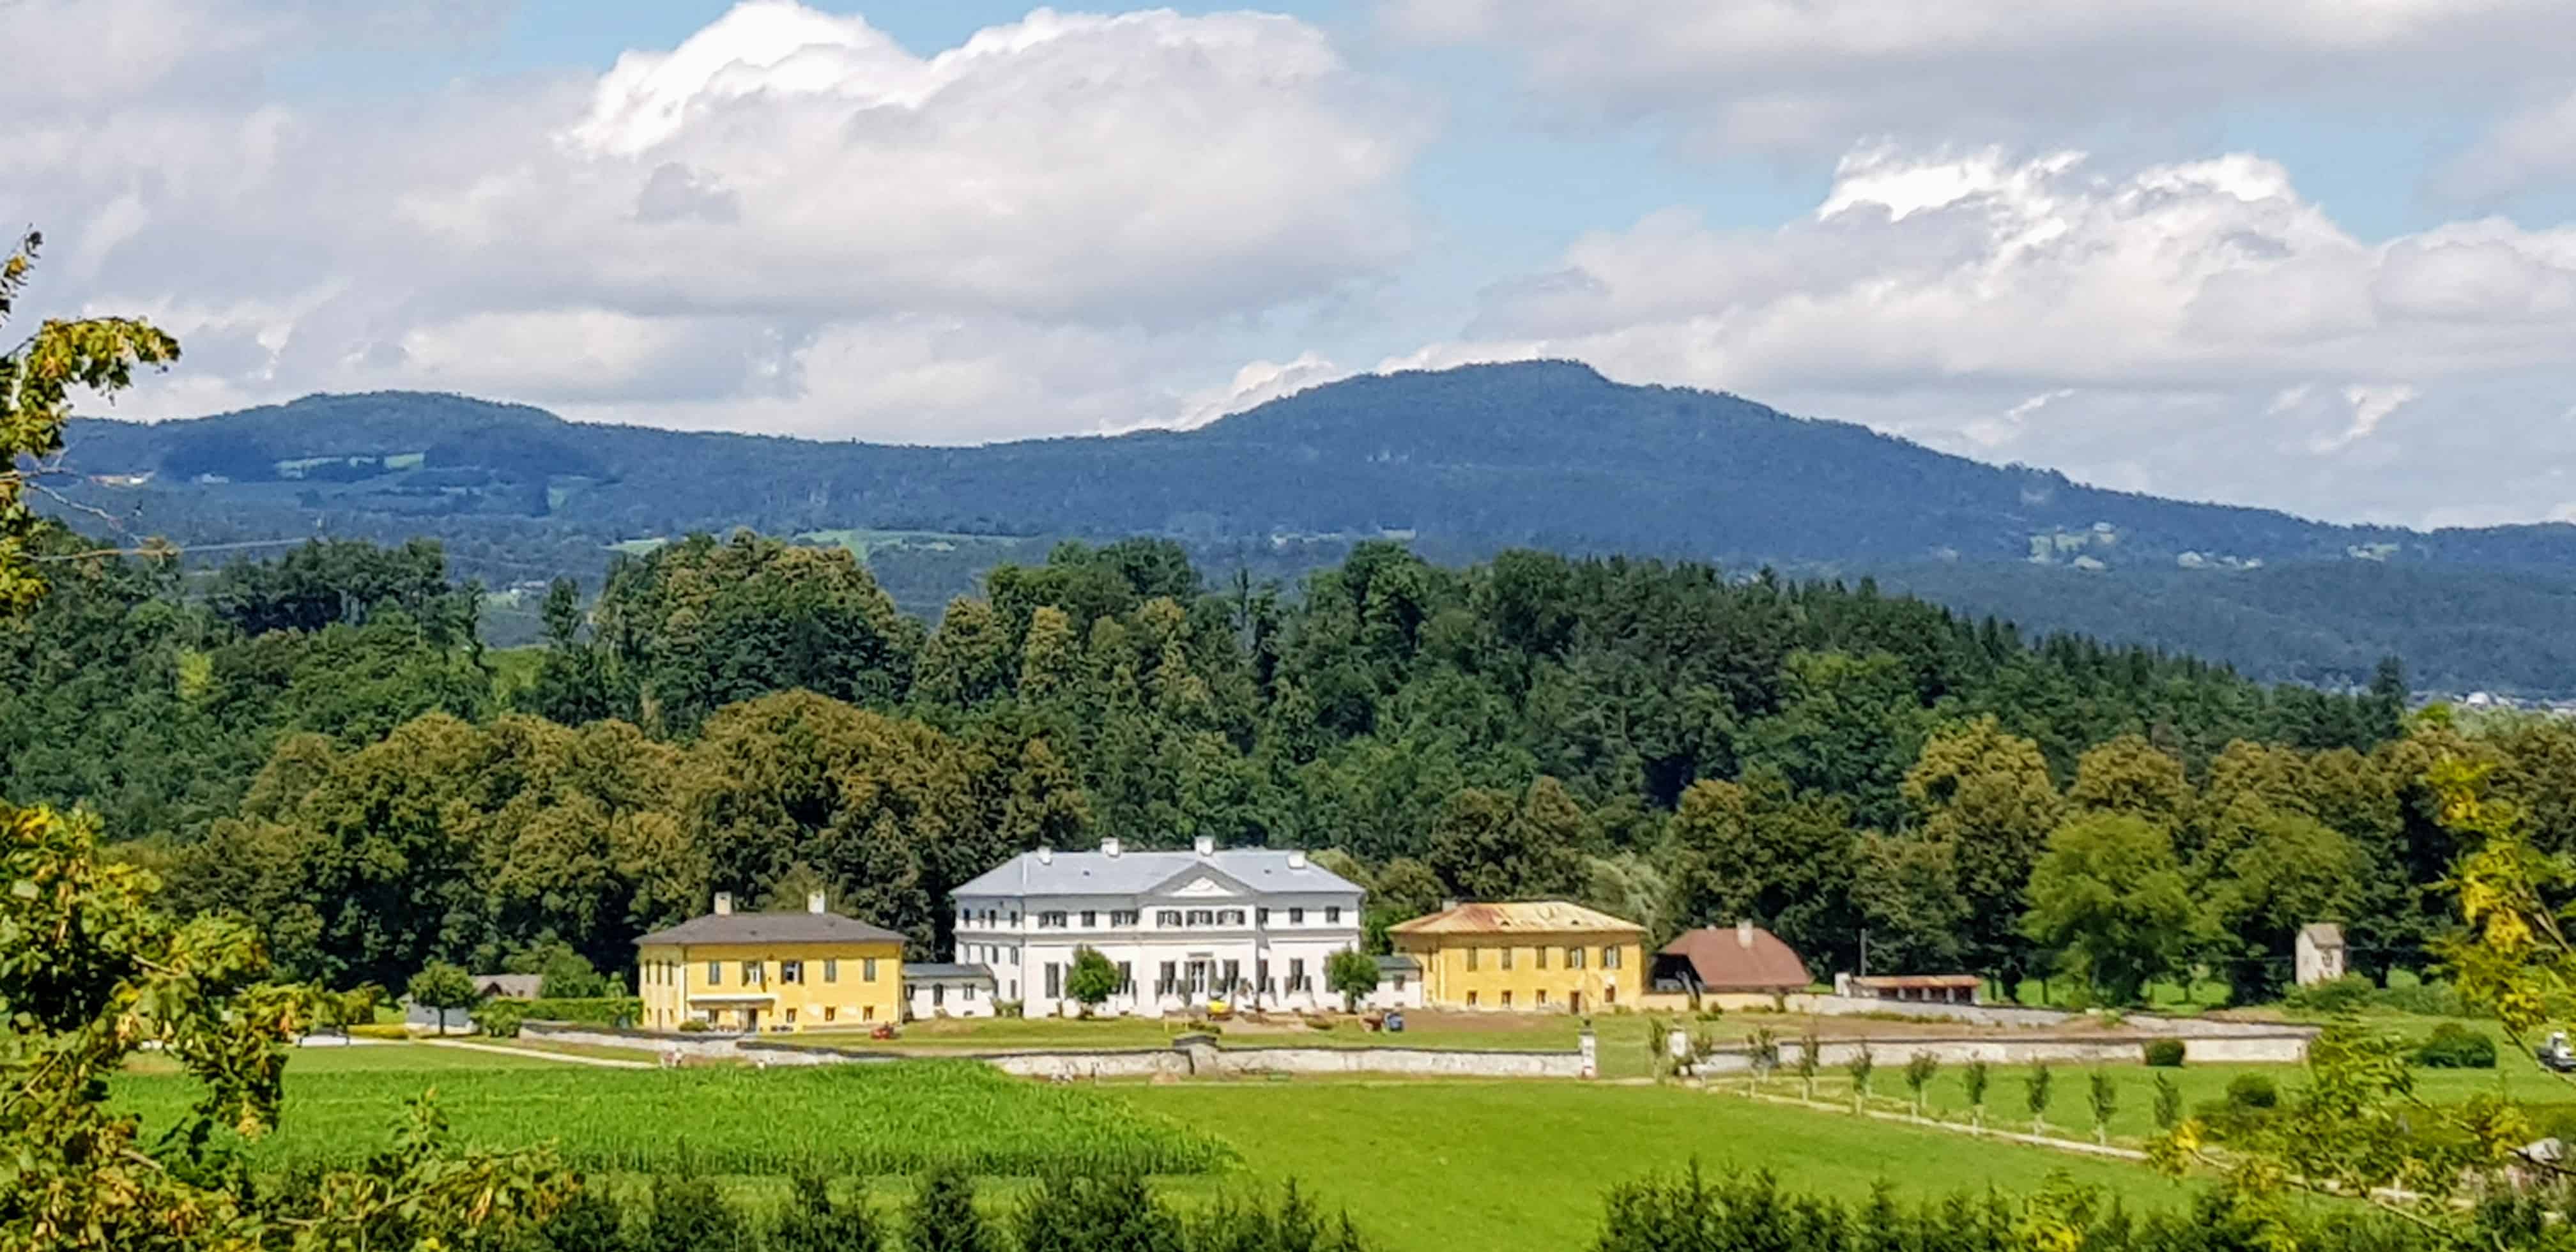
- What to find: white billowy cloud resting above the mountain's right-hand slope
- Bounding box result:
[1401,147,2576,521]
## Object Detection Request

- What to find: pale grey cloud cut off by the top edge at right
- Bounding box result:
[1378,0,2576,180]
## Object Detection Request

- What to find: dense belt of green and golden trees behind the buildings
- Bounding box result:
[20,517,2576,1009]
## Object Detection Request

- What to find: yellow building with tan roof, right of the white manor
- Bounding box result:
[1386,899,1646,1012]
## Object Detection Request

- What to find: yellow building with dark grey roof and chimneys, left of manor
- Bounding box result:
[636,891,904,1030]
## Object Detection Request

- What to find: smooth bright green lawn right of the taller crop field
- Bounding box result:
[1121,1082,2182,1252]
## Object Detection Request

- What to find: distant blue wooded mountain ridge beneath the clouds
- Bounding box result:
[50,363,2576,691]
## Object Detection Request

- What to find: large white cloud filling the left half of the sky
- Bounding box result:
[15,0,1430,443]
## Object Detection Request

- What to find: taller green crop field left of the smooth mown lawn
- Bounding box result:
[113,1046,1234,1175]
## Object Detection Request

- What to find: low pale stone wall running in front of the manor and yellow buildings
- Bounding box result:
[520,1023,1584,1080]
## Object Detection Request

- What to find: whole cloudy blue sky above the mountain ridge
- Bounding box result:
[0,0,2576,526]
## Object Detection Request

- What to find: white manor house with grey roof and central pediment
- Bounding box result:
[951,840,1360,1018]
